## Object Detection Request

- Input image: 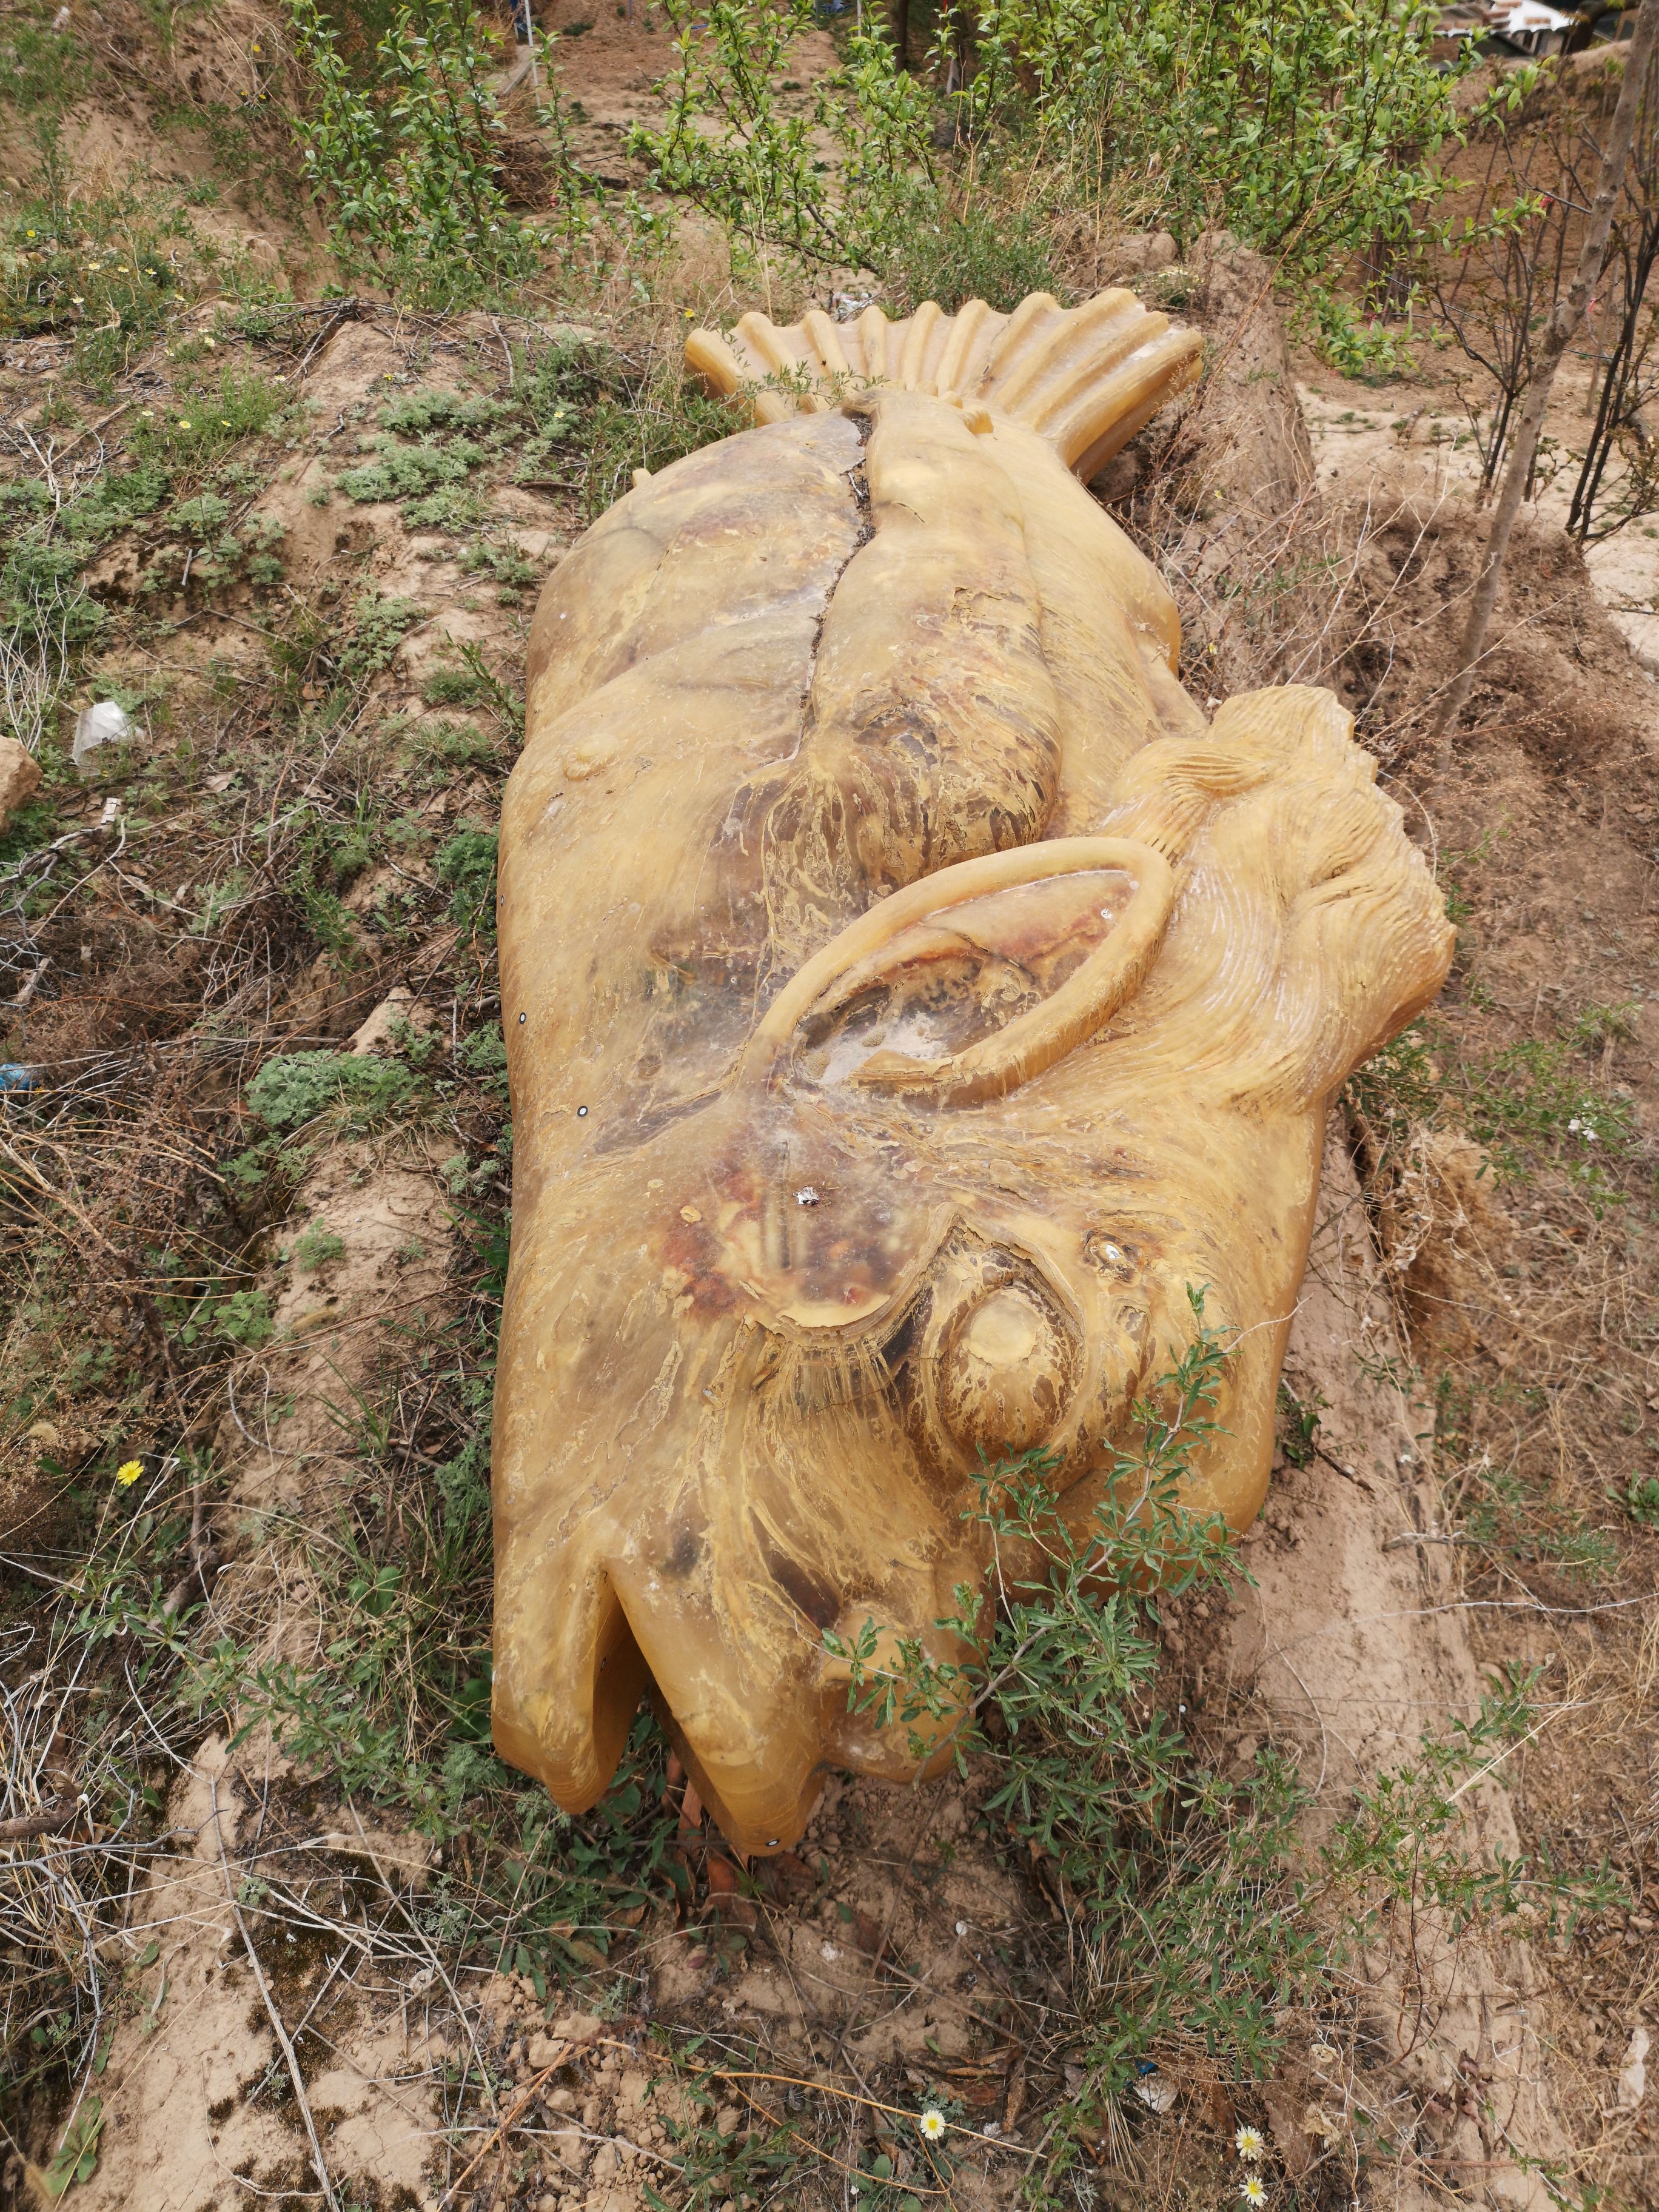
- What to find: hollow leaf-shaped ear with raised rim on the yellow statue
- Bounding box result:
[745,836,1175,1106]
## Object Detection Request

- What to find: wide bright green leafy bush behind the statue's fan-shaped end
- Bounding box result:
[632,0,1473,349]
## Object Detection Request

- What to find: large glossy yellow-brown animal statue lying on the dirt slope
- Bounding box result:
[494,292,1451,1849]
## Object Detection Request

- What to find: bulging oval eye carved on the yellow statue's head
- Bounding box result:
[936,1283,1078,1460]
